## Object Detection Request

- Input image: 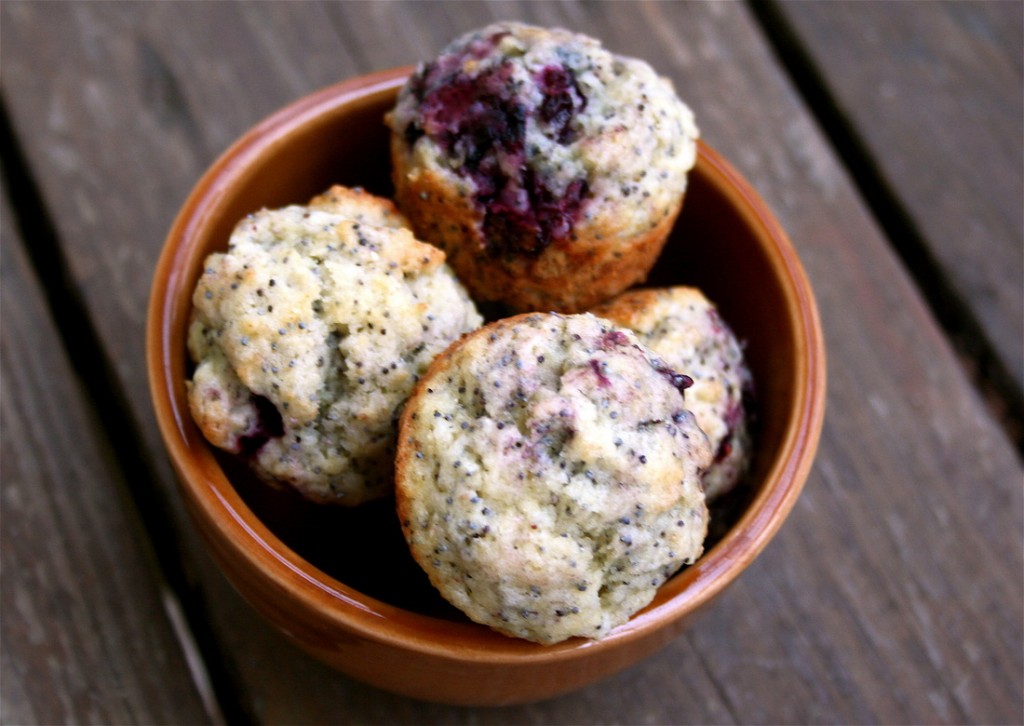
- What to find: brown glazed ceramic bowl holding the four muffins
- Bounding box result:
[146,69,825,704]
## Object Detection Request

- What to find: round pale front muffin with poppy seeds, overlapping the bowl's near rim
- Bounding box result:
[395,313,712,643]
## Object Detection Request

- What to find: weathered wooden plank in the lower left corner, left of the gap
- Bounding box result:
[0,185,210,724]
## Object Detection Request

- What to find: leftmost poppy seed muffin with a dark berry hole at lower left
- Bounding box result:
[187,187,482,505]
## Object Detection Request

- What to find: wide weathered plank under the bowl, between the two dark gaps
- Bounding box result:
[0,3,1024,723]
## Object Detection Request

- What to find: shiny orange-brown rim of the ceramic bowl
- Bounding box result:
[145,67,825,664]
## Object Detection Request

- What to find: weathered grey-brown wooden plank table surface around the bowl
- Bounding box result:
[0,0,1024,724]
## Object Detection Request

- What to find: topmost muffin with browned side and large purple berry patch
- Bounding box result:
[387,23,698,312]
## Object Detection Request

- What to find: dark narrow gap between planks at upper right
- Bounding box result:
[746,0,1024,458]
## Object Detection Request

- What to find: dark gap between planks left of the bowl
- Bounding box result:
[0,96,249,724]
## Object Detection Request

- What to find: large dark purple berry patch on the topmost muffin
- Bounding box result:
[404,51,589,255]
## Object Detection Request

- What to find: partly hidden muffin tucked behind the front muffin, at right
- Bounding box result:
[593,287,753,501]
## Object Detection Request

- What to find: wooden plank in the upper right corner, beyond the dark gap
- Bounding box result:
[778,1,1024,407]
